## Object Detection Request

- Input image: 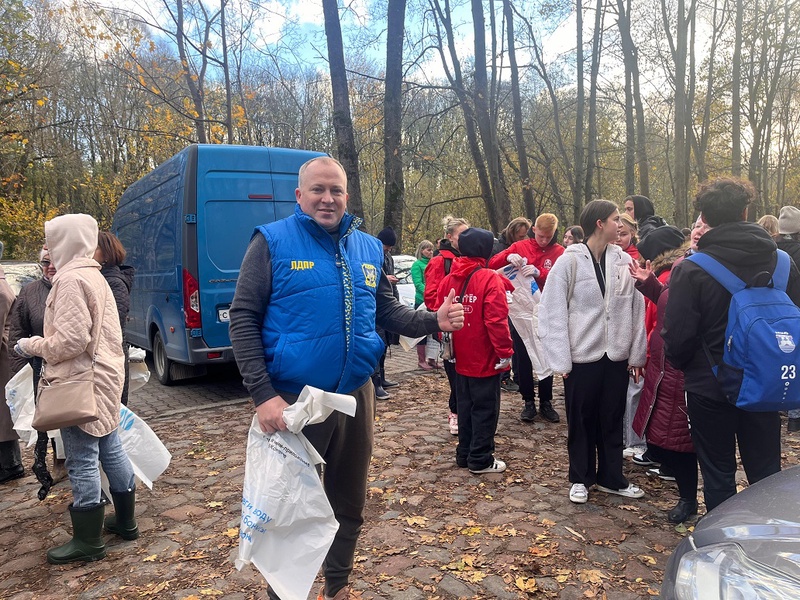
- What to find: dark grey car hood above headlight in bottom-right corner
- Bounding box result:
[692,466,800,579]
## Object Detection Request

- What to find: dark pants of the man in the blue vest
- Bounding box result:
[268,381,375,600]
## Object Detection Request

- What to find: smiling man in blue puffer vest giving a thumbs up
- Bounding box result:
[230,157,464,600]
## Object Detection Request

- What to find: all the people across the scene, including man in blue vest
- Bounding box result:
[0,157,800,600]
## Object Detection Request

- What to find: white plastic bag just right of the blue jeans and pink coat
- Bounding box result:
[117,406,172,490]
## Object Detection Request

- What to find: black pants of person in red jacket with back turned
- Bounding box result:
[456,373,500,470]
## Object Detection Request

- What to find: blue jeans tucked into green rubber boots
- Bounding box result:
[61,427,133,508]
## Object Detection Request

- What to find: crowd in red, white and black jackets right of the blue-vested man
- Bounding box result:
[392,178,800,523]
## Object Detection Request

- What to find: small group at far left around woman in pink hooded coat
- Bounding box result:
[0,214,139,564]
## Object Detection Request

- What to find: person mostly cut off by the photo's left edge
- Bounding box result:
[0,251,20,484]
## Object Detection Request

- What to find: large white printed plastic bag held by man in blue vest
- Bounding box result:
[235,386,356,600]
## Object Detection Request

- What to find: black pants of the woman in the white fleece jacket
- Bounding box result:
[564,355,628,490]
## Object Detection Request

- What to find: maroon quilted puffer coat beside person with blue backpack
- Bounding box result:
[633,254,694,452]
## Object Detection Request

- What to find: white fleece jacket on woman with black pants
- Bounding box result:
[539,244,647,373]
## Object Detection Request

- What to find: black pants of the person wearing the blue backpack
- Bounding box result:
[686,392,781,510]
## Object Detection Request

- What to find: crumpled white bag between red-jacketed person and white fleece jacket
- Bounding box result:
[503,265,553,379]
